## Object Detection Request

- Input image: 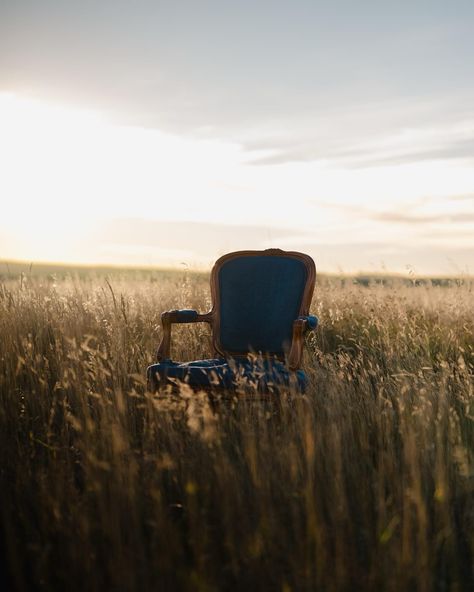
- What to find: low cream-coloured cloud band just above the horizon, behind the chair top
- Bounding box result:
[90,219,474,274]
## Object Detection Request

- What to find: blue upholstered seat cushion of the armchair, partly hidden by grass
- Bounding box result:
[147,358,307,392]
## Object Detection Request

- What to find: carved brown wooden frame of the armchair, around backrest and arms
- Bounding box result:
[156,249,316,370]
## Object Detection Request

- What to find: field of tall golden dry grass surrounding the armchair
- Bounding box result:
[0,267,474,592]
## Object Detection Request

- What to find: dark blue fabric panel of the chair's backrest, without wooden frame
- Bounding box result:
[218,255,307,354]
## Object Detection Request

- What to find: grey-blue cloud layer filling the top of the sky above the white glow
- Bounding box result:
[0,0,474,167]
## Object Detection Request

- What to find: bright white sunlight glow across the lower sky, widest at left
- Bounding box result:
[0,94,474,274]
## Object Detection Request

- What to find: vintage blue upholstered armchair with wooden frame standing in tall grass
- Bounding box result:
[147,249,318,393]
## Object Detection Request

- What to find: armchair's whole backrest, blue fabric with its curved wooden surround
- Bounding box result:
[211,249,316,358]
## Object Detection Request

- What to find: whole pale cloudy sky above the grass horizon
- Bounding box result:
[0,0,474,275]
